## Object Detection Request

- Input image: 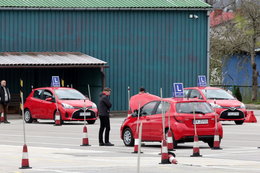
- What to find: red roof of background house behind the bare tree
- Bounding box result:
[210,10,235,27]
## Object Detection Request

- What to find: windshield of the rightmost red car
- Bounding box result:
[202,89,235,100]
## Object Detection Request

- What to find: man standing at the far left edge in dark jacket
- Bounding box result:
[0,80,11,123]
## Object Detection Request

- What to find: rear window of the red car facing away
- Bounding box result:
[176,102,214,114]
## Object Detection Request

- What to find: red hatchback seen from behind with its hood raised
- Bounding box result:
[120,95,223,147]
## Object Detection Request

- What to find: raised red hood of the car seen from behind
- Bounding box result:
[129,93,161,112]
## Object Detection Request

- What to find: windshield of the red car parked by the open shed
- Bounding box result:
[55,89,86,100]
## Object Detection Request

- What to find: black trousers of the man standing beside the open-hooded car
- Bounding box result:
[99,116,110,144]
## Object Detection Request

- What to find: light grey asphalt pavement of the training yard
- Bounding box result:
[0,110,260,173]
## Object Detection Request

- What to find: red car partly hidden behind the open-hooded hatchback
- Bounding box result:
[184,87,246,125]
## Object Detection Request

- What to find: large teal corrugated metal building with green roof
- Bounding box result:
[0,0,211,110]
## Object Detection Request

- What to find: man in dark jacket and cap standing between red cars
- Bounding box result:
[98,88,114,146]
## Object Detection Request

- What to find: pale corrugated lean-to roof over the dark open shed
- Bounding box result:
[0,52,106,68]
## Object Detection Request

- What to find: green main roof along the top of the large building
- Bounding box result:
[0,0,211,9]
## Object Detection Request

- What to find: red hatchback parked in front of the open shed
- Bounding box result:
[24,87,97,124]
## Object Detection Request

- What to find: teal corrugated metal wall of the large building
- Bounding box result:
[0,10,207,110]
